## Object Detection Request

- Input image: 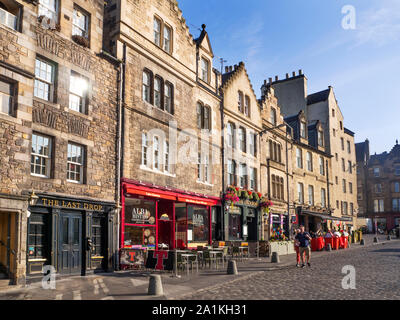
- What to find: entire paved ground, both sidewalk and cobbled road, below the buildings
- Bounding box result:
[0,235,400,300]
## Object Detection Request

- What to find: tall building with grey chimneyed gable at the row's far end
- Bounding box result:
[263,70,358,227]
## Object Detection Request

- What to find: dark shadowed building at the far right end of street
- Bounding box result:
[356,140,400,232]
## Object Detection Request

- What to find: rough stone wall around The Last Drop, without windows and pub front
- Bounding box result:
[0,0,118,282]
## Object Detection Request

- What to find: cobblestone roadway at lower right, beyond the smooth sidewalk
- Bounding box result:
[184,241,400,300]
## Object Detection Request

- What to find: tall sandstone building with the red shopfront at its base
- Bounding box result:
[105,0,222,255]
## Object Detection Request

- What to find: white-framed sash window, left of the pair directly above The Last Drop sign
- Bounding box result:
[31,133,52,178]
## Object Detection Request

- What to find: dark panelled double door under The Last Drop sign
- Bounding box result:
[59,213,82,274]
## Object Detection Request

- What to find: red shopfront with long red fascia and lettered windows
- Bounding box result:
[120,182,219,250]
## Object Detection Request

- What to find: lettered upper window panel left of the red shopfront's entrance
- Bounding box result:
[125,199,156,224]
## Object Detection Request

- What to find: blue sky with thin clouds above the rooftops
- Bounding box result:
[178,0,400,154]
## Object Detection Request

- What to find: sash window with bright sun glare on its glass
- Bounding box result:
[69,71,88,113]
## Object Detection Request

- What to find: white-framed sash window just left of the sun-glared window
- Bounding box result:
[33,58,55,101]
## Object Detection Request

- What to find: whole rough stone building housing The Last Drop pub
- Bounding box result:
[0,0,118,283]
